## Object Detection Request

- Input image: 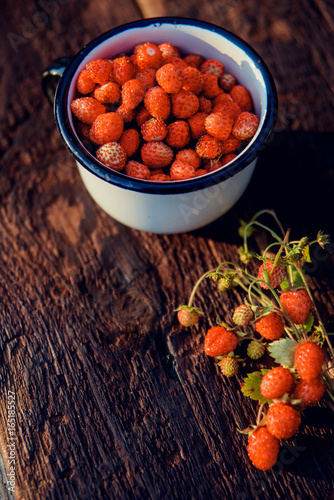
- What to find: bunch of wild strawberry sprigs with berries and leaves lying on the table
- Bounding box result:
[177,210,334,470]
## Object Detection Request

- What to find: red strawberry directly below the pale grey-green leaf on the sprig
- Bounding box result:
[260,366,295,399]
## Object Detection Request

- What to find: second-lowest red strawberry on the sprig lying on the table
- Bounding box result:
[266,403,301,439]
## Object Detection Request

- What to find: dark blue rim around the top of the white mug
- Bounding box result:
[54,17,277,194]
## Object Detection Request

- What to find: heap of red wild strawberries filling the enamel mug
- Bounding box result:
[71,42,259,181]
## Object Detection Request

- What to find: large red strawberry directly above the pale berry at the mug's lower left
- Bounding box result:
[90,113,124,145]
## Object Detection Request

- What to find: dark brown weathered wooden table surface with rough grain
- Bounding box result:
[0,0,334,500]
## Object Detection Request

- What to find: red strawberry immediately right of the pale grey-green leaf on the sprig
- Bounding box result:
[295,341,325,381]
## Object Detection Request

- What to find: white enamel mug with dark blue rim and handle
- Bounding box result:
[43,17,277,234]
